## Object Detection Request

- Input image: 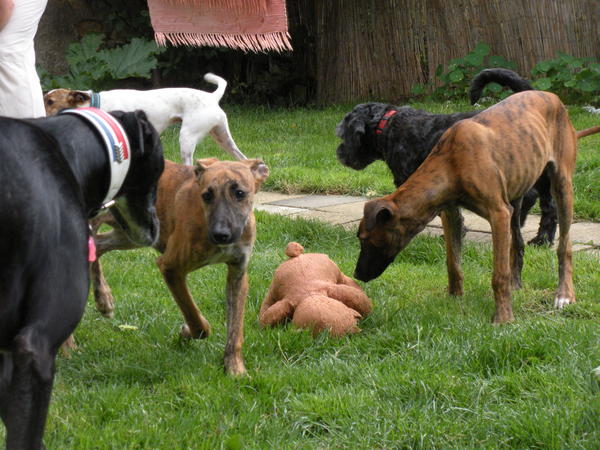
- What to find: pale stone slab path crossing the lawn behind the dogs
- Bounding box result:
[256,192,600,256]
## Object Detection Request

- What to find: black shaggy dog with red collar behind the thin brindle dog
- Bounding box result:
[336,68,557,245]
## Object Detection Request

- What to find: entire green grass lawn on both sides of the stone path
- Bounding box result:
[0,100,600,449]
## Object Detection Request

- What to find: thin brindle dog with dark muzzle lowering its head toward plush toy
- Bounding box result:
[355,91,600,323]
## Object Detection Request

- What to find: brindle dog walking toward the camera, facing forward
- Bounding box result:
[91,158,269,375]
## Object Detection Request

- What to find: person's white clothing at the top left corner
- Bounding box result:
[0,0,48,118]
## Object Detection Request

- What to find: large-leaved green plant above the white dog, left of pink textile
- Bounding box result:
[39,34,164,90]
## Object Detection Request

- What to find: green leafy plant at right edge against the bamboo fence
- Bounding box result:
[531,52,600,102]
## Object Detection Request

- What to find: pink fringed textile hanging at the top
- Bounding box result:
[148,0,292,52]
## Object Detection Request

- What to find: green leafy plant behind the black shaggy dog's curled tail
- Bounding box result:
[411,42,517,99]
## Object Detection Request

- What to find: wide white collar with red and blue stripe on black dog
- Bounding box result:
[60,107,131,205]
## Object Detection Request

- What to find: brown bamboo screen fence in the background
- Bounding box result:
[300,0,600,103]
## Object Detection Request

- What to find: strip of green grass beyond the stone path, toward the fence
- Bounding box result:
[163,103,600,221]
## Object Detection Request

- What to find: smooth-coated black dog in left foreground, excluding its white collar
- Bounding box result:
[0,112,164,449]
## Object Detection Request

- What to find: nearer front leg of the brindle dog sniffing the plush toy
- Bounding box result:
[489,205,514,324]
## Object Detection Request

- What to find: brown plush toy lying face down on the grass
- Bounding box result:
[259,242,373,336]
